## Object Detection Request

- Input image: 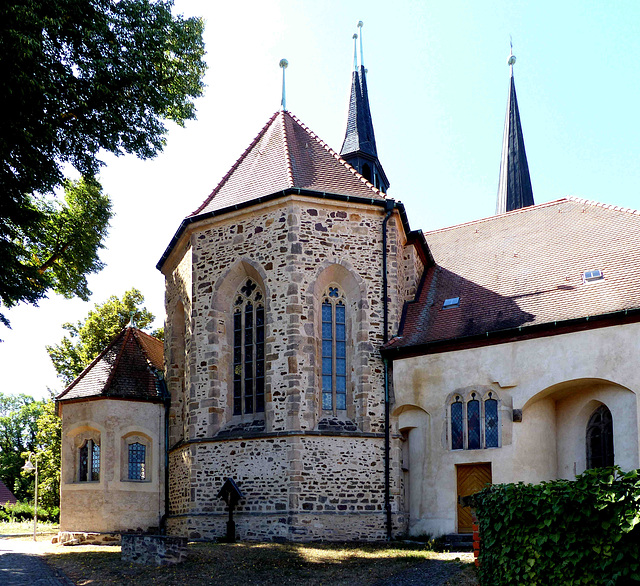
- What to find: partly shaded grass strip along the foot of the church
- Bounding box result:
[20,538,477,586]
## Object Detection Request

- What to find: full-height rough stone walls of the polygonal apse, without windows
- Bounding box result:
[165,196,419,538]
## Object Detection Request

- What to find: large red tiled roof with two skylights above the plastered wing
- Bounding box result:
[391,198,640,347]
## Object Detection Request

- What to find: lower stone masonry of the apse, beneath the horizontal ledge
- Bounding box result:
[169,435,404,541]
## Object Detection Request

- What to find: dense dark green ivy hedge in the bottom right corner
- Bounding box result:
[471,467,640,586]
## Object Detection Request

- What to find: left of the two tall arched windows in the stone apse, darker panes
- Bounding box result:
[233,279,264,415]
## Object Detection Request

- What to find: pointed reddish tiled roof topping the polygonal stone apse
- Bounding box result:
[191,111,384,216]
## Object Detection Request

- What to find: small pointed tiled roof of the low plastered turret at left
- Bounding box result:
[57,328,163,401]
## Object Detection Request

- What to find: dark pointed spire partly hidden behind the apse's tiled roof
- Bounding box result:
[340,21,389,193]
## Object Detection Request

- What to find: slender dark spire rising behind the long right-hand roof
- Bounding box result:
[496,45,533,214]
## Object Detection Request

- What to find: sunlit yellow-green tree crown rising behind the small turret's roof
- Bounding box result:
[47,289,162,385]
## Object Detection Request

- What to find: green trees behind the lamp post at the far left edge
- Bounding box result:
[0,393,45,500]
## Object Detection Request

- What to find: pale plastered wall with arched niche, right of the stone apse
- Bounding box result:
[393,324,640,535]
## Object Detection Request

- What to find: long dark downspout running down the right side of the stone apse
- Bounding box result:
[382,199,395,541]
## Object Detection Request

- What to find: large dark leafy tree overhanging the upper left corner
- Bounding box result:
[0,0,205,320]
